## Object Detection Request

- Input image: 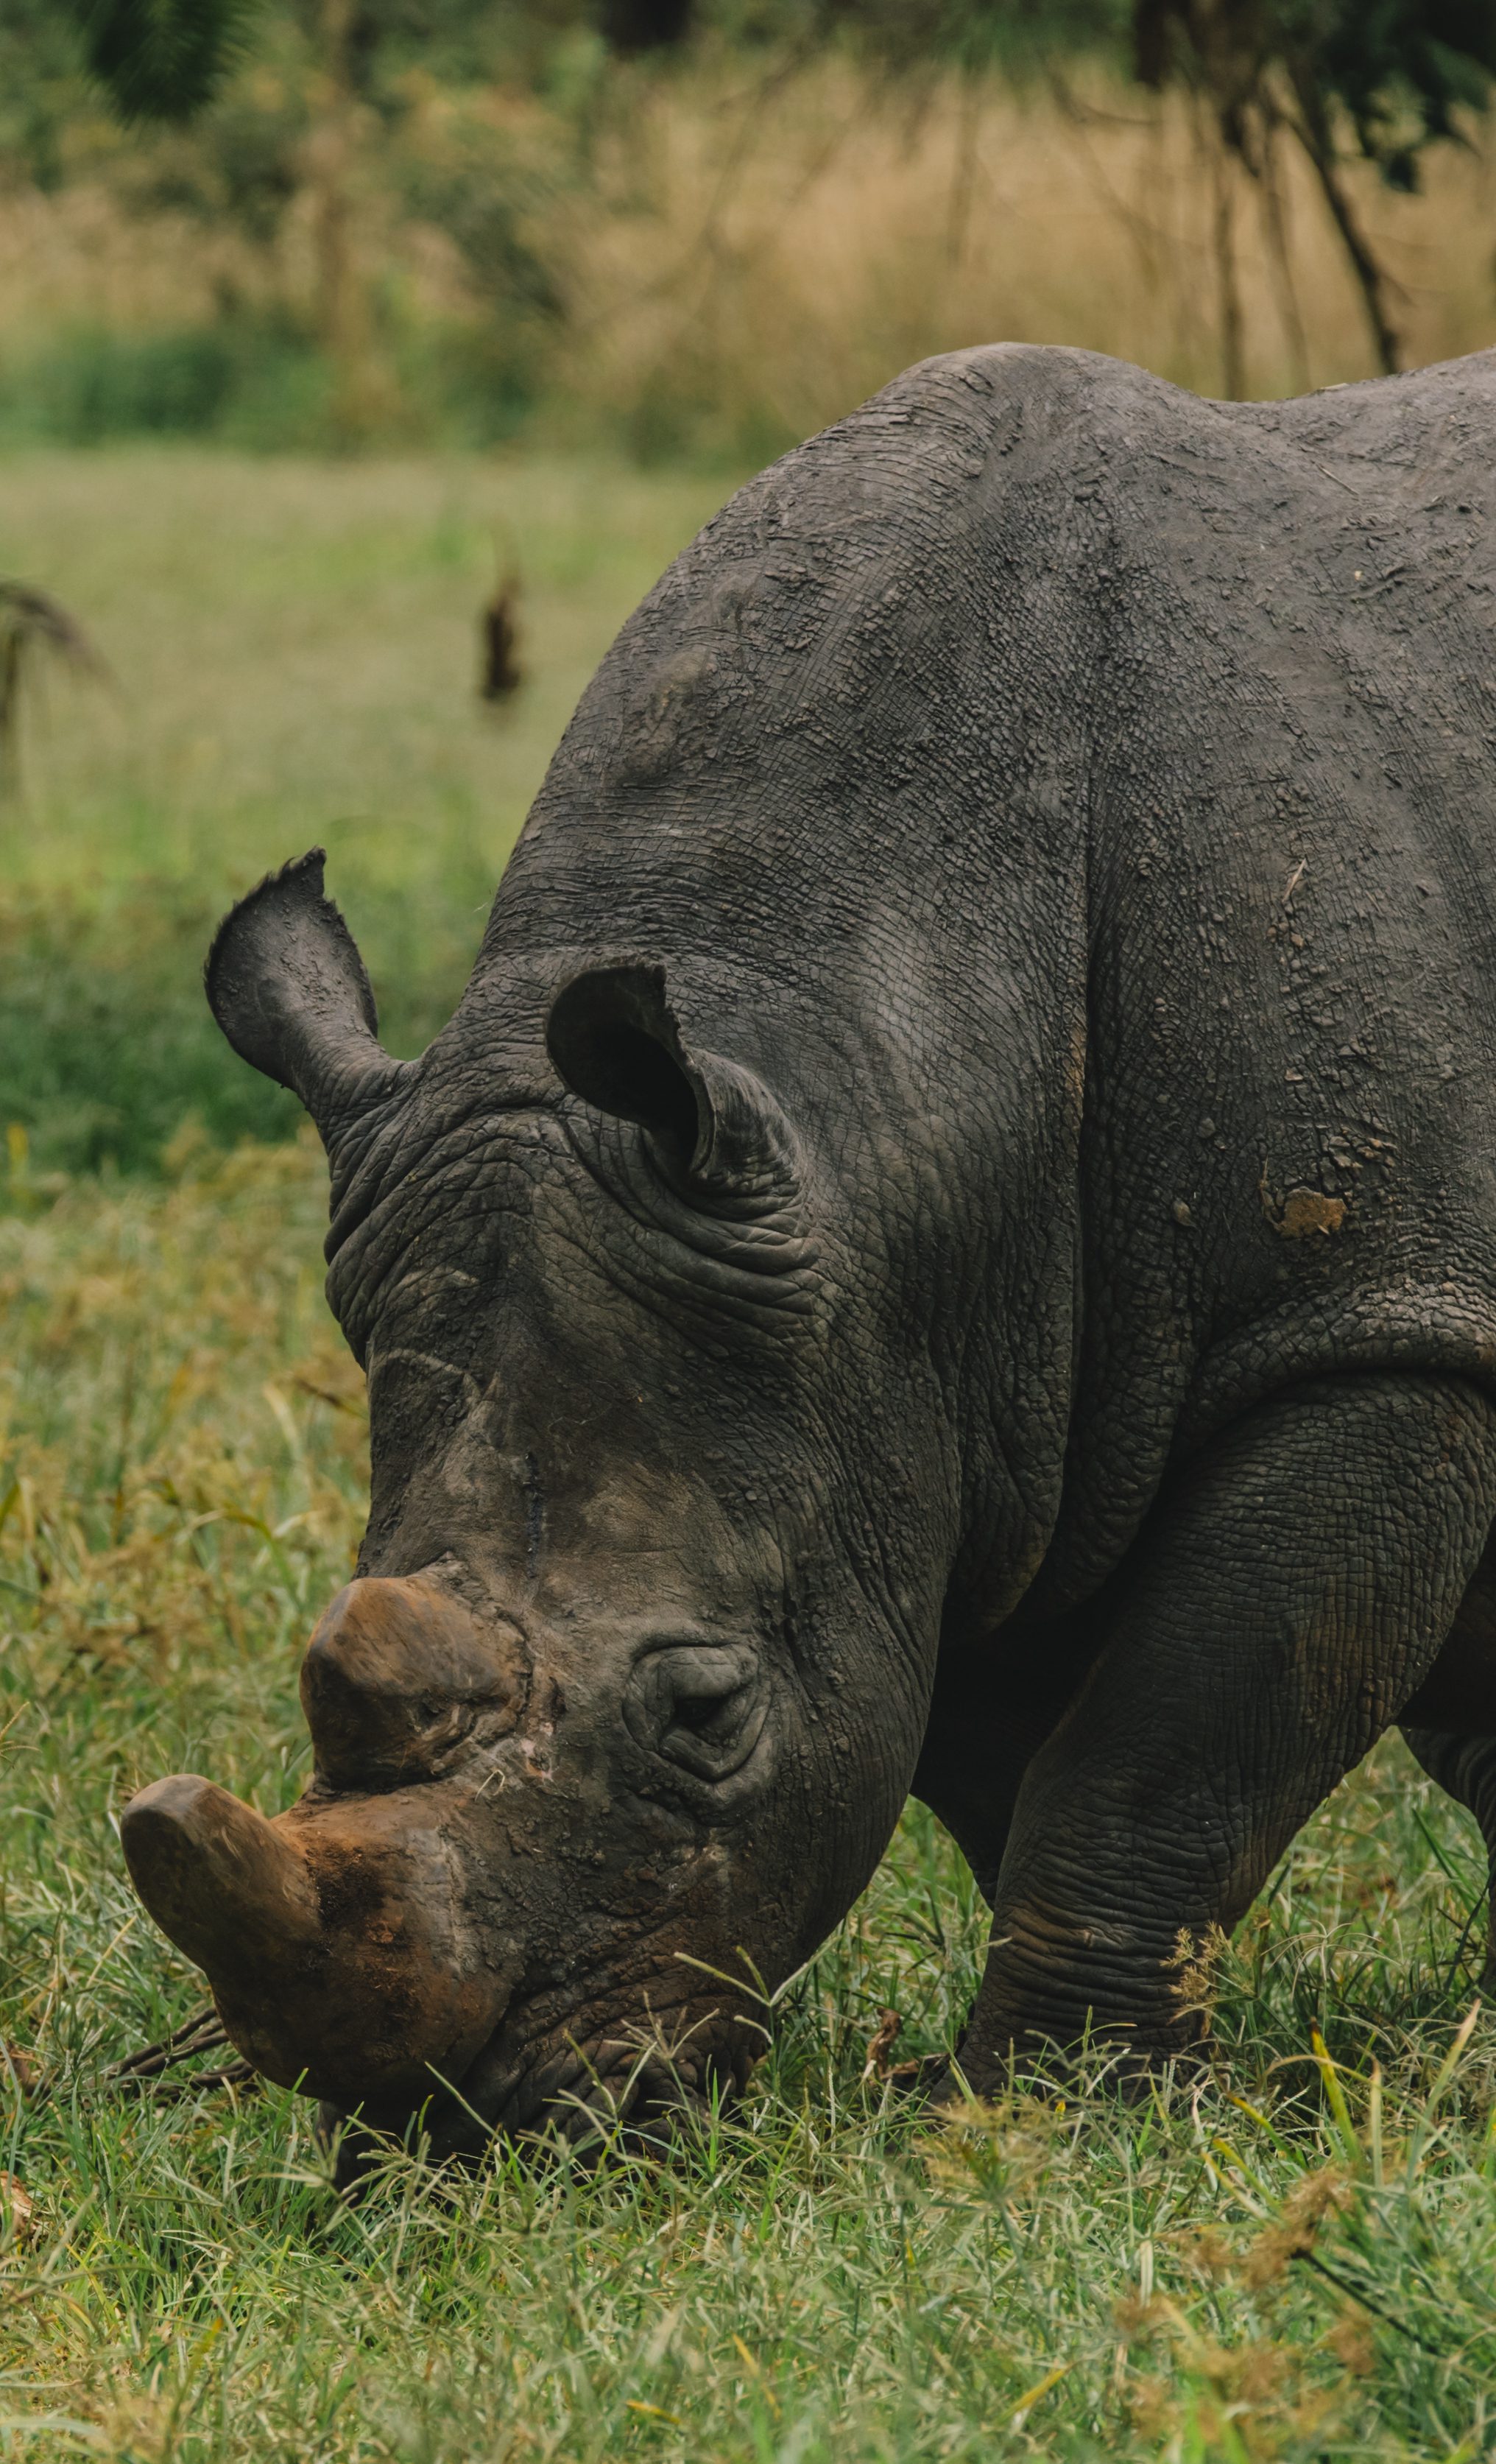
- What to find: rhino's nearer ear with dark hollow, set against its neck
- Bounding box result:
[545,966,799,1212]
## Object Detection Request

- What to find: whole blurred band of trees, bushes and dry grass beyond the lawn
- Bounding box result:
[0,0,1496,471]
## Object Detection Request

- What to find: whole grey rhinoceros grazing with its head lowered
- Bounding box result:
[123,348,1496,2149]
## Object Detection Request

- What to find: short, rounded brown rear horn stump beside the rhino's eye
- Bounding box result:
[300,1574,530,1789]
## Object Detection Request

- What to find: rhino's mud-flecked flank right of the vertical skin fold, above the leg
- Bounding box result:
[1035,355,1496,1607]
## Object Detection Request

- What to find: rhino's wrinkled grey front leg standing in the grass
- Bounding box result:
[959,1375,1496,2089]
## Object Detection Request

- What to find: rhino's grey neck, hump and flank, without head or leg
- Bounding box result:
[451,348,1496,1616]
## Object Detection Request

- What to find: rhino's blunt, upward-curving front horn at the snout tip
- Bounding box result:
[121,1772,323,1984]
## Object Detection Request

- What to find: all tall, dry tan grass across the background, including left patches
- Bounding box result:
[0,64,1496,446]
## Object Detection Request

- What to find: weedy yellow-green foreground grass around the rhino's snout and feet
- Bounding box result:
[0,1144,1496,2464]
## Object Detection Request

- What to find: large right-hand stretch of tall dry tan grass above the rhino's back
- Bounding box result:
[557,74,1496,432]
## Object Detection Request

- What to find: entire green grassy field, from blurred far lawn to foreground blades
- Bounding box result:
[0,454,1496,2464]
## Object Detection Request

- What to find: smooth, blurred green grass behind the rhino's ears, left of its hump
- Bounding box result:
[0,446,724,1170]
